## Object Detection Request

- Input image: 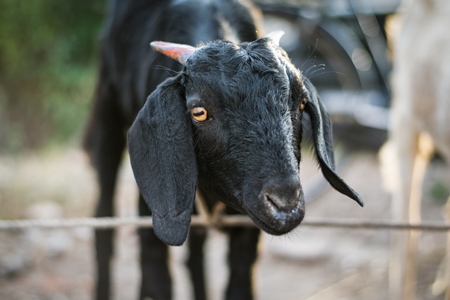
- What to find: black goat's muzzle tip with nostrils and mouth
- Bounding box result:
[247,198,305,235]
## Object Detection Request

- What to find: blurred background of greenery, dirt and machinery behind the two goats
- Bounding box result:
[0,0,450,300]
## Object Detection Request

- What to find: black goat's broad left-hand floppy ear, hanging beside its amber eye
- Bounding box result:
[128,77,197,246]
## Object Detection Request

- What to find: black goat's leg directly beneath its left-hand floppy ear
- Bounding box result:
[139,196,172,300]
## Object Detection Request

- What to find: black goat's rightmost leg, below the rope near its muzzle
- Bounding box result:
[226,227,260,300]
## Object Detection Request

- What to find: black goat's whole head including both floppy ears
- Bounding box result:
[129,38,362,245]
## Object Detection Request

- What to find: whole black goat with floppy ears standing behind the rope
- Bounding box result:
[85,0,362,300]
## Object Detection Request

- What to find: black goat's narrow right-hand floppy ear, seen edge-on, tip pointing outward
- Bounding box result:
[302,79,364,206]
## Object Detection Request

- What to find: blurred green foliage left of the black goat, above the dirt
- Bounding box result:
[0,0,106,151]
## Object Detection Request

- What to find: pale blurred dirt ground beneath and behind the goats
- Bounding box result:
[0,145,450,300]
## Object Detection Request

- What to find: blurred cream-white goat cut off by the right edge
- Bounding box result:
[382,0,450,300]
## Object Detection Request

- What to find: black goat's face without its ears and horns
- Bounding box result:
[184,39,305,234]
